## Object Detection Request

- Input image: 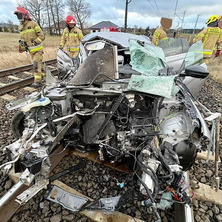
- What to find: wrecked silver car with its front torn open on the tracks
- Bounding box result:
[0,33,219,221]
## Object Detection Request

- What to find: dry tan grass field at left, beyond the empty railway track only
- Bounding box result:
[0,32,60,70]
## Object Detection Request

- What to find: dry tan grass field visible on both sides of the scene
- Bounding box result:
[0,32,222,84]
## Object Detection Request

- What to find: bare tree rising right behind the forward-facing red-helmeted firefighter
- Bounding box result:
[67,0,91,34]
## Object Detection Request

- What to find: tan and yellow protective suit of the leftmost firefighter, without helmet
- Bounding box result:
[19,20,45,82]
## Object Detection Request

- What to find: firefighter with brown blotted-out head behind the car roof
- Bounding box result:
[152,17,172,46]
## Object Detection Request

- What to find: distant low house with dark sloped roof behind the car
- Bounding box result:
[89,21,120,33]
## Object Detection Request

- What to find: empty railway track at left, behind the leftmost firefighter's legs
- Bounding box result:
[0,59,57,96]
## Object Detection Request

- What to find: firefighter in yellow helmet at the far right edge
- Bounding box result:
[193,15,222,64]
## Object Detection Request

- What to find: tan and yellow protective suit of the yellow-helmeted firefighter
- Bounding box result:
[193,27,222,64]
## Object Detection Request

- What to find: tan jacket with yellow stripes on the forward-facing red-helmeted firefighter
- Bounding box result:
[60,26,83,52]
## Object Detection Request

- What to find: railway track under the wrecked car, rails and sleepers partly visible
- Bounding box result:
[0,146,194,222]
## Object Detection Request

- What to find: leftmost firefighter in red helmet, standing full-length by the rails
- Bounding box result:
[14,7,45,87]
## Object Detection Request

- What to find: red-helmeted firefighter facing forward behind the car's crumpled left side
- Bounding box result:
[59,15,83,58]
